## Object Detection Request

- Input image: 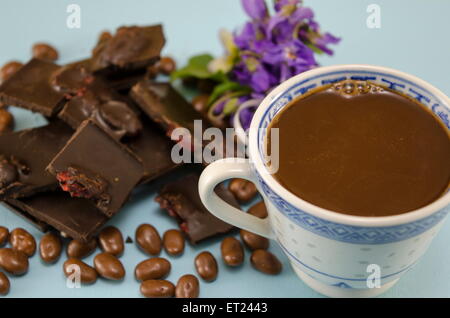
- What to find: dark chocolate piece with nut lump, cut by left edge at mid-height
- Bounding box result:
[0,121,73,199]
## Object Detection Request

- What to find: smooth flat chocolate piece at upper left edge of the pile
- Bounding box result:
[0,58,64,117]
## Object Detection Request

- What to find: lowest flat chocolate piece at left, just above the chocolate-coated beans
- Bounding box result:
[8,191,108,242]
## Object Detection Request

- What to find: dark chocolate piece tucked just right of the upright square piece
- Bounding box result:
[125,119,179,183]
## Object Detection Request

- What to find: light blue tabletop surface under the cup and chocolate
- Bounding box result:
[0,0,450,297]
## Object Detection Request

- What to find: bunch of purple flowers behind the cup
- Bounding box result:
[210,0,340,128]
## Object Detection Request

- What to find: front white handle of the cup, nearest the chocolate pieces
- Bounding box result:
[198,158,274,239]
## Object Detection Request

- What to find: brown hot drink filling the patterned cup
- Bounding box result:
[267,81,450,216]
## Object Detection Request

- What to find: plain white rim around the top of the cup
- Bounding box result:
[248,64,450,227]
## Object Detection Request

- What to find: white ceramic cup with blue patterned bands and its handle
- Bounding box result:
[199,65,450,297]
